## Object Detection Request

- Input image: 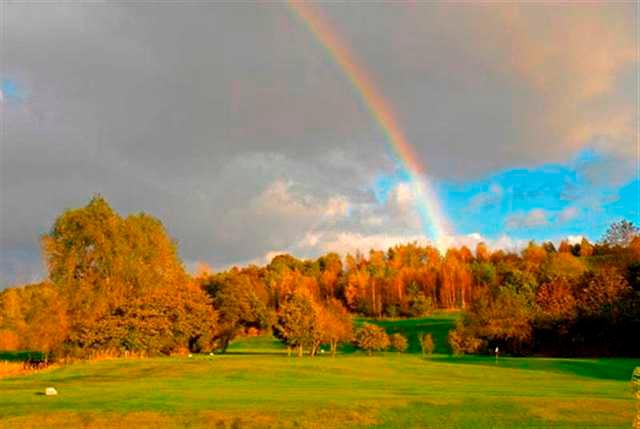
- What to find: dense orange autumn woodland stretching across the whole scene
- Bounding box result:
[0,196,640,357]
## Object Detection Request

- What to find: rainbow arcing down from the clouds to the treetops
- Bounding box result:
[289,0,452,250]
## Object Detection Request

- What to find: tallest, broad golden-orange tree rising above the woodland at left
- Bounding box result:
[42,196,216,353]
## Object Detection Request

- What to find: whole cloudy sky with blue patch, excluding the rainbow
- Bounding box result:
[0,0,640,288]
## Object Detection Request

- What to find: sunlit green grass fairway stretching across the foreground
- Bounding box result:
[0,316,640,428]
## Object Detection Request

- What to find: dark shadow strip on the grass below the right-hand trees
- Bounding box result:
[430,355,640,381]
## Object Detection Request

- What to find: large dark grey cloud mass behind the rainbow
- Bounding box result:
[0,1,633,287]
